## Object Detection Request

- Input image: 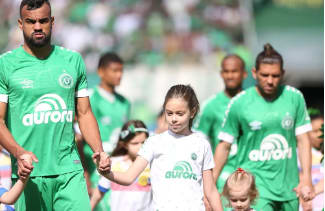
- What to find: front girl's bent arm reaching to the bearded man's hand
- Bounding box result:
[102,156,148,185]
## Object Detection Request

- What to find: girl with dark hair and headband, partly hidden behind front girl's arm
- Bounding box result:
[90,120,152,211]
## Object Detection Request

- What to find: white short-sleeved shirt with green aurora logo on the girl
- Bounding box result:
[138,130,214,211]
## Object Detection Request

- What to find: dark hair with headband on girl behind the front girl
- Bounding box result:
[112,120,149,156]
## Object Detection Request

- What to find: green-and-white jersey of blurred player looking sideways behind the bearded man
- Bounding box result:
[84,87,131,185]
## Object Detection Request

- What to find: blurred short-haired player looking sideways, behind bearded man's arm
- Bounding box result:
[79,52,131,211]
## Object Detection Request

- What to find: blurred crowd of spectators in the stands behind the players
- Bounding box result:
[0,0,250,72]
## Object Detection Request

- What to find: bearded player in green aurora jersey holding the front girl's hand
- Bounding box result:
[0,0,110,211]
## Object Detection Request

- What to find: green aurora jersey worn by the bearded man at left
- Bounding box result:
[0,46,88,177]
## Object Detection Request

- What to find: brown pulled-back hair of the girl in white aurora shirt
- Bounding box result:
[163,84,200,129]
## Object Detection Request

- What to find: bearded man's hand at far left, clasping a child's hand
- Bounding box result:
[16,150,38,180]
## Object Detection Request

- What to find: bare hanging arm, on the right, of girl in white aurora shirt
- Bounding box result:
[202,169,223,211]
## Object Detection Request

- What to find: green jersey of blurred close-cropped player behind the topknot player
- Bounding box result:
[194,92,237,192]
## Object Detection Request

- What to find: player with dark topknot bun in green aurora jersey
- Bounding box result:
[215,44,313,211]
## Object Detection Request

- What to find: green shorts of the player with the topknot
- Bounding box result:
[253,198,299,211]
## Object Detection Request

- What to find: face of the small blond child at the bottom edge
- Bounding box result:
[229,191,251,211]
